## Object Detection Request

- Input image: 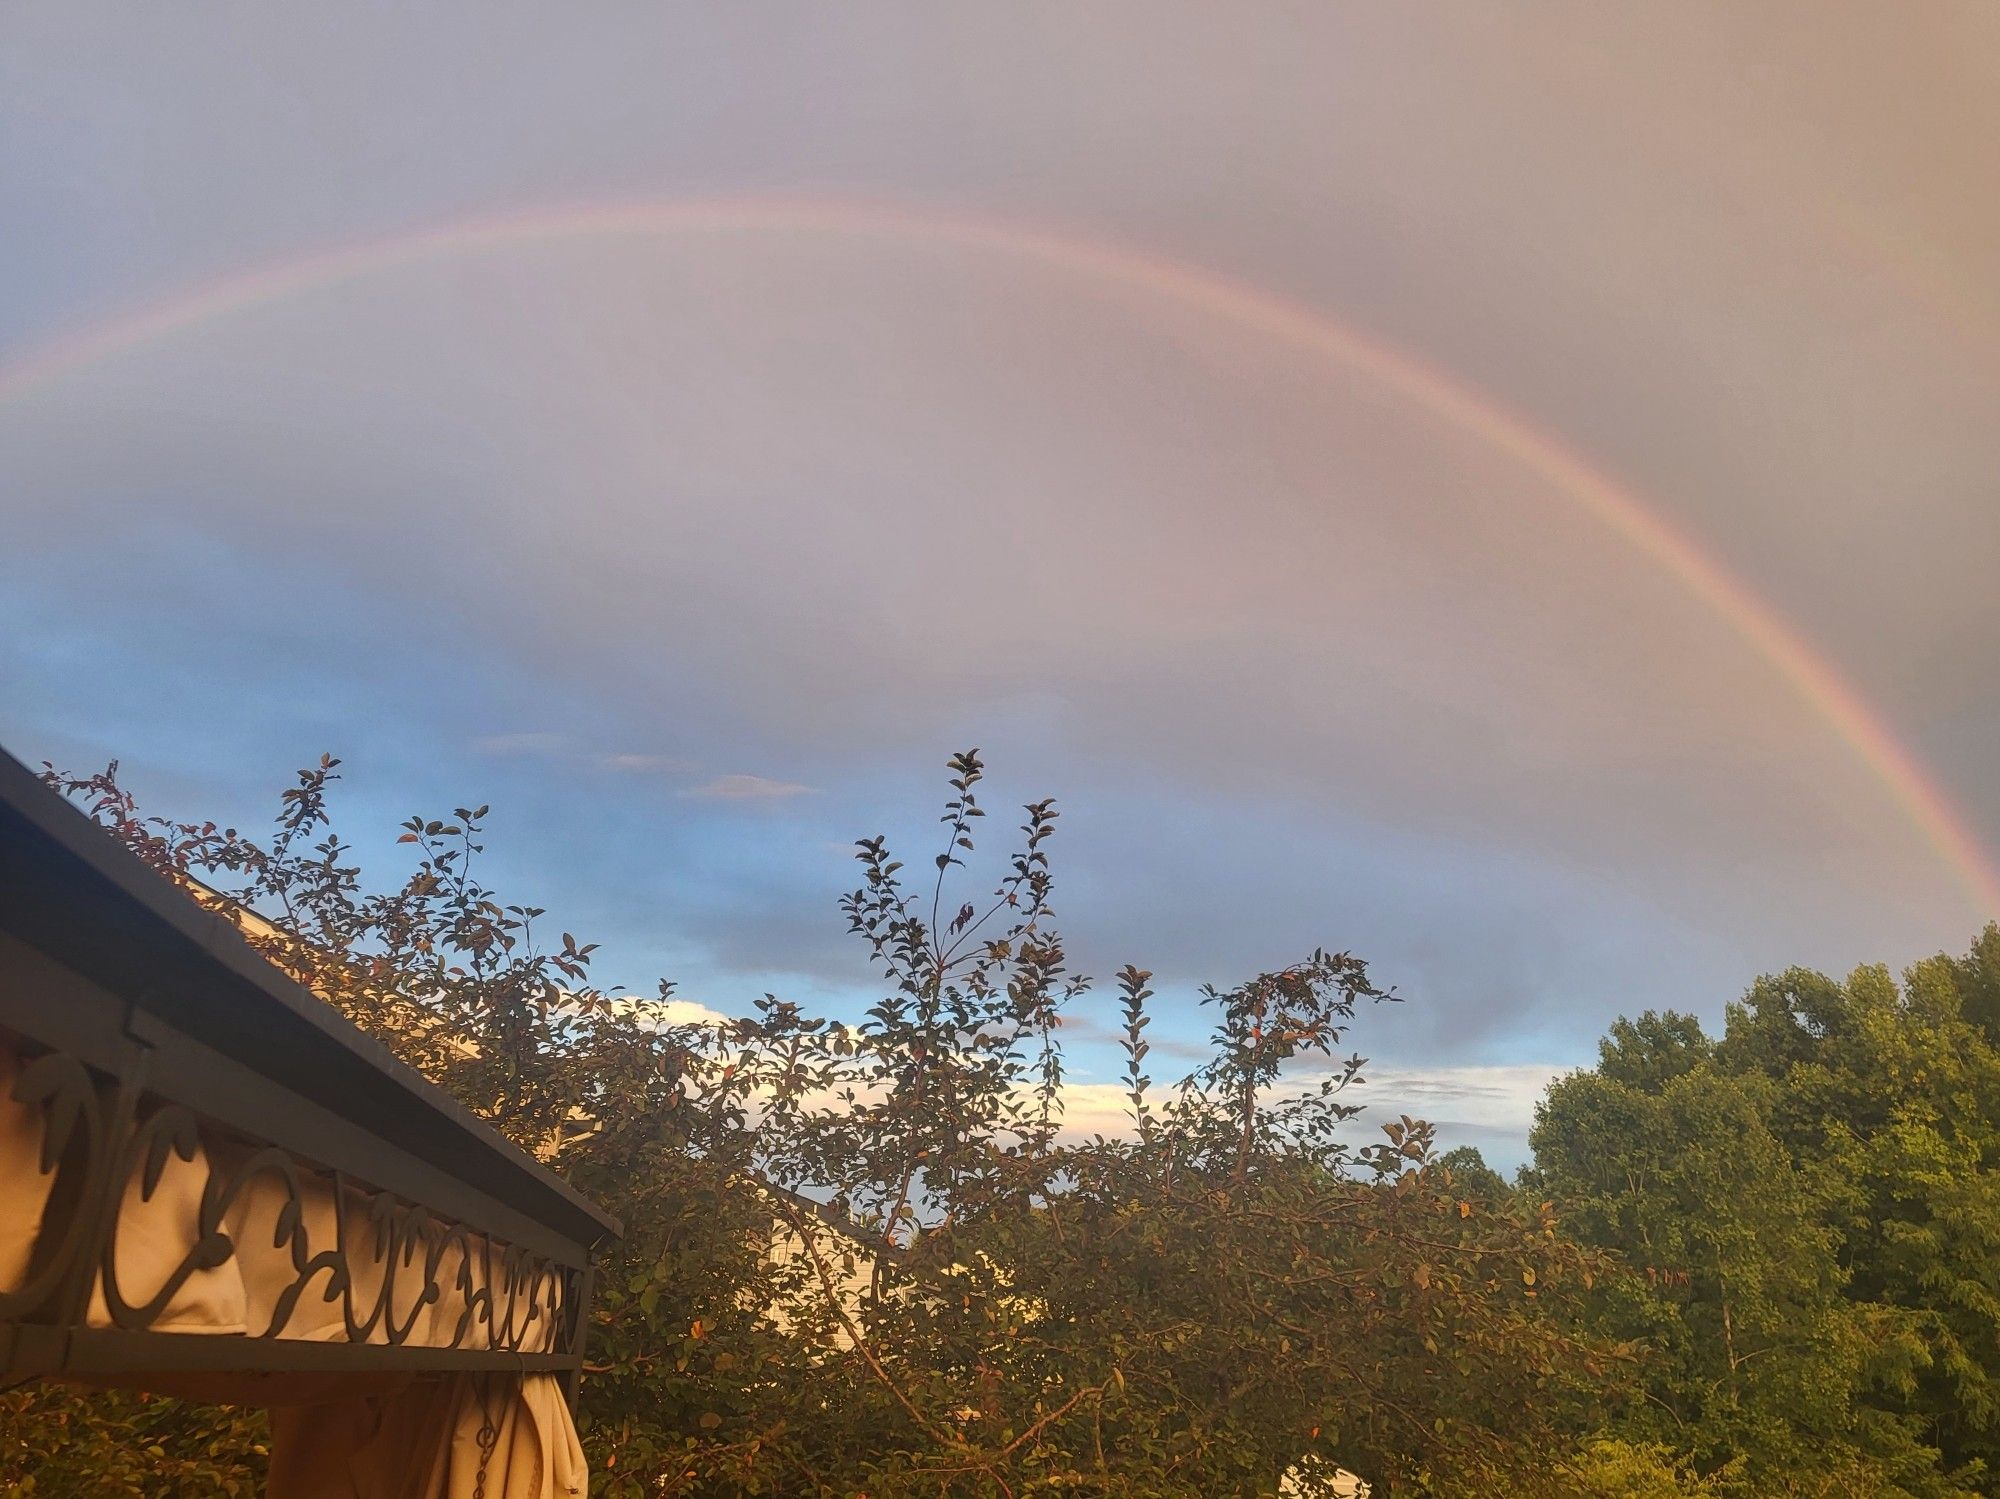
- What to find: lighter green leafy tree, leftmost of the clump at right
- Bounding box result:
[1532,1061,1932,1495]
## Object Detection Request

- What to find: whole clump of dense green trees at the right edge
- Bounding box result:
[1532,927,2000,1495]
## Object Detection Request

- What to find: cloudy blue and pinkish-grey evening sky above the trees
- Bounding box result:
[0,0,2000,1163]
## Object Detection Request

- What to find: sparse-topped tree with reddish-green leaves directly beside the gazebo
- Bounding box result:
[8,751,1624,1497]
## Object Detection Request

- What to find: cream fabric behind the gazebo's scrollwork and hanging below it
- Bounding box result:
[0,1041,586,1499]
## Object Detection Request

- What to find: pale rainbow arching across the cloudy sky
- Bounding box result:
[0,198,2000,915]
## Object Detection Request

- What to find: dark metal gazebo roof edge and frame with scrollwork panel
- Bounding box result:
[0,753,618,1397]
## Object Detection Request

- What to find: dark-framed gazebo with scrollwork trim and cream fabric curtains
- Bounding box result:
[0,753,618,1499]
